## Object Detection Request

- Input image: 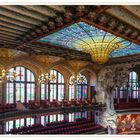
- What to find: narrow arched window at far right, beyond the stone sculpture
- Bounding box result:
[128,71,139,99]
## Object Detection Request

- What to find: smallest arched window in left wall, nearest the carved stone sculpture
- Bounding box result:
[69,74,88,100]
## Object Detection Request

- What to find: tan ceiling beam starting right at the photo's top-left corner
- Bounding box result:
[0,5,46,21]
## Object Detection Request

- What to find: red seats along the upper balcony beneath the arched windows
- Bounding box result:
[0,99,96,113]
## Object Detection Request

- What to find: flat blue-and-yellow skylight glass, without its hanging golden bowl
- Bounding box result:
[38,22,140,58]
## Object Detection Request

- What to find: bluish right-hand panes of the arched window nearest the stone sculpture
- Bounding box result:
[76,75,88,100]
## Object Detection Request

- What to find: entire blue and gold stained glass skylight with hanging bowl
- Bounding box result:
[39,22,140,63]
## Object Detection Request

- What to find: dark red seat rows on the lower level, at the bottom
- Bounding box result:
[8,118,102,134]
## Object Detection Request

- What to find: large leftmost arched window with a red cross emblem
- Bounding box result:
[6,66,35,103]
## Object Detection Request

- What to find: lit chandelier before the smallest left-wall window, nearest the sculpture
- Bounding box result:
[70,73,86,85]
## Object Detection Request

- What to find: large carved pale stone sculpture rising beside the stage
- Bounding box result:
[96,64,132,128]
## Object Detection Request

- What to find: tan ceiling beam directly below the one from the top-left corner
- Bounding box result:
[0,7,41,25]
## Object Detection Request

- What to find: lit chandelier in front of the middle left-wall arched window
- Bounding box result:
[38,73,56,84]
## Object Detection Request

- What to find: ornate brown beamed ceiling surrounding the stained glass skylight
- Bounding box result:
[0,5,140,61]
